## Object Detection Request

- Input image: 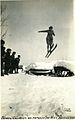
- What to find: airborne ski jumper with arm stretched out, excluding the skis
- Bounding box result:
[38,26,55,52]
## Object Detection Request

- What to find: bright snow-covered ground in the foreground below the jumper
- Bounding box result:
[1,73,75,117]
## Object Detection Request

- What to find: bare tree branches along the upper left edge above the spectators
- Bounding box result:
[0,2,8,39]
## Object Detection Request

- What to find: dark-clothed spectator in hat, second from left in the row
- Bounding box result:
[5,48,11,75]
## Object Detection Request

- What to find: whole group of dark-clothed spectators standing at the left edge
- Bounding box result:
[1,39,20,76]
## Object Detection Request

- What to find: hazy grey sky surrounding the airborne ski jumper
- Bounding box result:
[2,0,74,64]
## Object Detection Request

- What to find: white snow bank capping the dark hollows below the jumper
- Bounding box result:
[26,60,75,73]
